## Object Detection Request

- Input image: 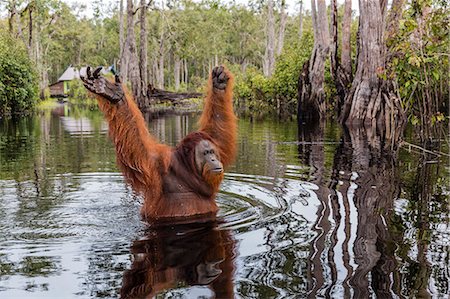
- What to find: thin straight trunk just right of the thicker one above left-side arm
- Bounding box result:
[139,0,148,104]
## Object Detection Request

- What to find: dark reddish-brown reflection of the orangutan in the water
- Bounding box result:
[120,223,234,298]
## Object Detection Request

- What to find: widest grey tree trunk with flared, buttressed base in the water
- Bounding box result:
[342,0,404,145]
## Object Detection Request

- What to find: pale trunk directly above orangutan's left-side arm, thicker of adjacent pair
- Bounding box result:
[126,0,143,107]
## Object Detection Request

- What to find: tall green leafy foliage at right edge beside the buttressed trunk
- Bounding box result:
[389,0,450,126]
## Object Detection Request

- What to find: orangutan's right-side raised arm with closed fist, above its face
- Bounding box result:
[199,66,237,166]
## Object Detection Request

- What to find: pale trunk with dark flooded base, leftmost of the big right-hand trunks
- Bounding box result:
[299,0,330,119]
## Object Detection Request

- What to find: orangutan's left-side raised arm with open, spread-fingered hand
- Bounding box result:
[81,67,170,196]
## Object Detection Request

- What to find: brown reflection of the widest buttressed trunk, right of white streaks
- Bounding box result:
[349,128,400,298]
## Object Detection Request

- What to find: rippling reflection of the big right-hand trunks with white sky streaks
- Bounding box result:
[299,121,399,298]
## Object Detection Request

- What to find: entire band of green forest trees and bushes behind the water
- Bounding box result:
[0,0,450,135]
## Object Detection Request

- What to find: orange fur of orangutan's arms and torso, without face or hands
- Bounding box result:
[96,67,237,221]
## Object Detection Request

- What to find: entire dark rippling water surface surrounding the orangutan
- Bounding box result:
[0,106,450,298]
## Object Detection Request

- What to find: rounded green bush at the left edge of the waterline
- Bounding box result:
[0,33,38,115]
